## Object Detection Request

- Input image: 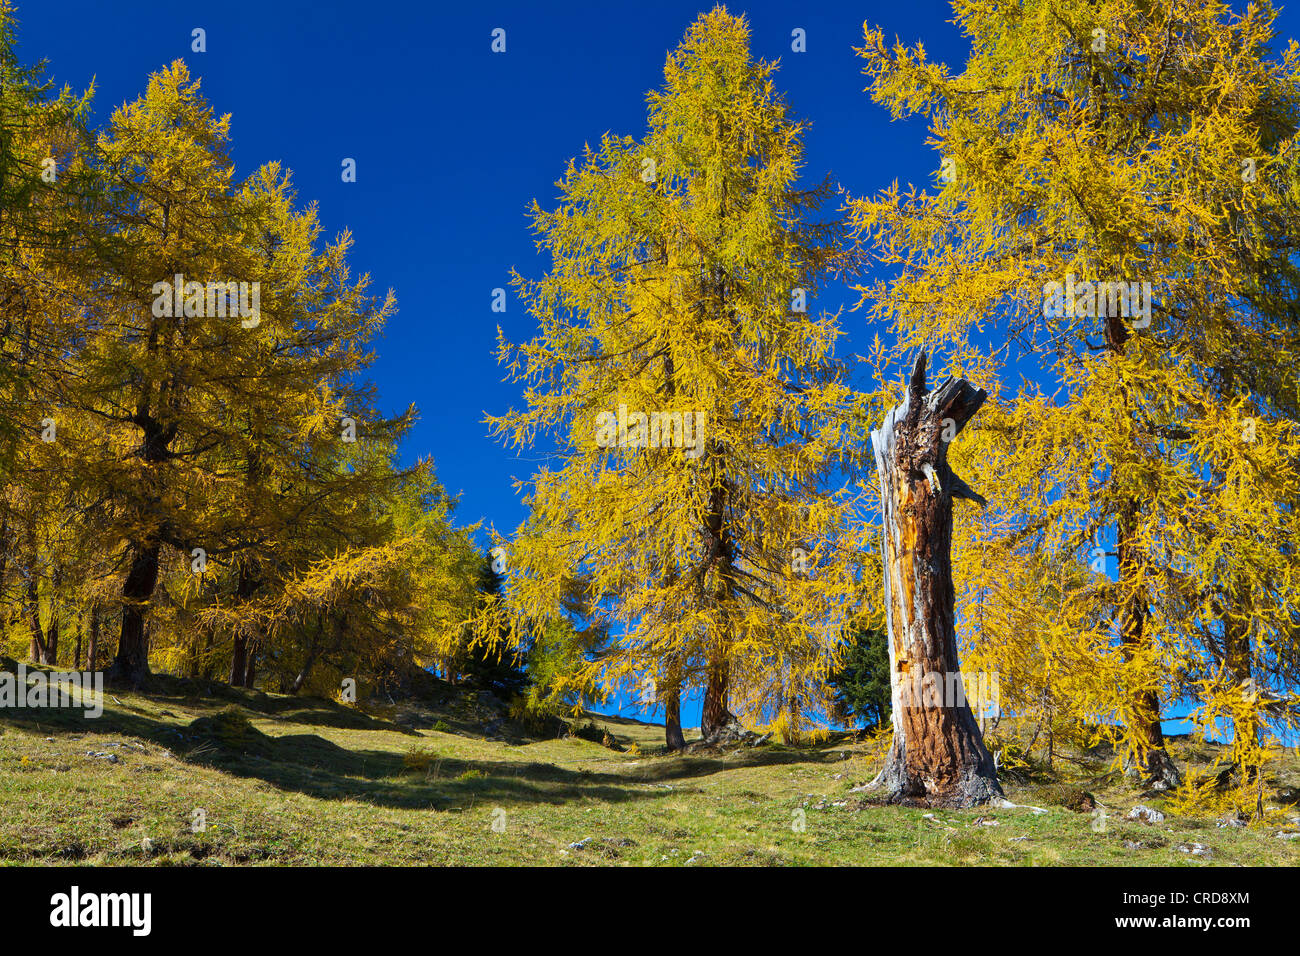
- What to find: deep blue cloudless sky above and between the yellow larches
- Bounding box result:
[17,0,1300,738]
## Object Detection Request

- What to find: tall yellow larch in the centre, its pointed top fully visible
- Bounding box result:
[489,7,854,745]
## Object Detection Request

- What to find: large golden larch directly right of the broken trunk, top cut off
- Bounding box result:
[854,0,1300,788]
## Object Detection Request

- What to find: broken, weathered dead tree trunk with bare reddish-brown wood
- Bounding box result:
[871,354,1002,806]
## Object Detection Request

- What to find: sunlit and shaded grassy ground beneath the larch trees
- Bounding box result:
[0,678,1300,866]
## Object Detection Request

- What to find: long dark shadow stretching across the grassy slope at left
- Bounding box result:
[0,679,837,810]
